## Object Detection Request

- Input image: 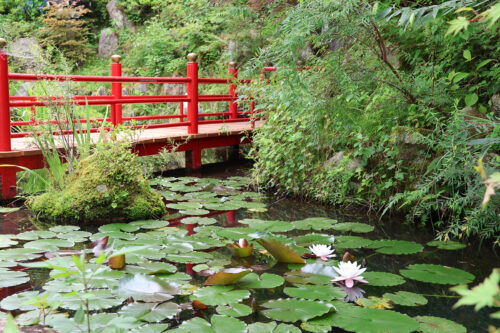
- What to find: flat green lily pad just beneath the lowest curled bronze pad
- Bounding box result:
[190,286,250,305]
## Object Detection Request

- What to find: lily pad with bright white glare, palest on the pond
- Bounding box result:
[119,274,181,302]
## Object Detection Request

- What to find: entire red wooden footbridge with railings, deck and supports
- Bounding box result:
[0,39,292,198]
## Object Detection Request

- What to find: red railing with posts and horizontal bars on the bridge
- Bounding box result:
[0,39,266,151]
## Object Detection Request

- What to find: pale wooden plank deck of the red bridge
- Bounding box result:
[0,120,262,159]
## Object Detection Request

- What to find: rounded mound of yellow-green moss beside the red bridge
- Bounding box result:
[28,144,166,223]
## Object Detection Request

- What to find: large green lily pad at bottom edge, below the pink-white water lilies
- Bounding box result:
[332,306,419,333]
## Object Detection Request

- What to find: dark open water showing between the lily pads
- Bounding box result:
[0,161,500,332]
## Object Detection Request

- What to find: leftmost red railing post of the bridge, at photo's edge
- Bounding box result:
[0,38,12,151]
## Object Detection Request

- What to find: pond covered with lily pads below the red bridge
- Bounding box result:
[0,164,498,332]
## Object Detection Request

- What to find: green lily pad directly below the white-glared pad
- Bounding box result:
[118,302,181,323]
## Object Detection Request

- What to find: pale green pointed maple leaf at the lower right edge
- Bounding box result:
[451,268,500,311]
